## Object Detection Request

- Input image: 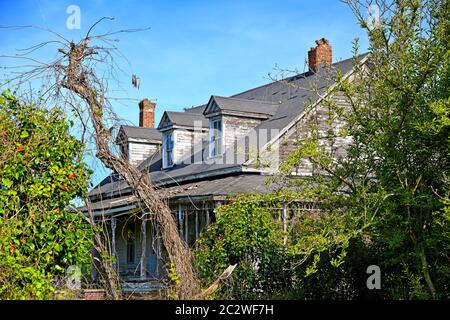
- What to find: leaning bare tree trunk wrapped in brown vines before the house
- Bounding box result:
[60,38,198,299]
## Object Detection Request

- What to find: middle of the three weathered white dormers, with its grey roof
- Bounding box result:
[158,111,208,169]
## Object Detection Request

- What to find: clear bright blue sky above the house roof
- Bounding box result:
[0,0,367,185]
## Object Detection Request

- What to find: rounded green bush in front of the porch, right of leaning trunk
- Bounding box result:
[195,195,288,299]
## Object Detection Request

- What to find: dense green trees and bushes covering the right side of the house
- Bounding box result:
[196,0,450,299]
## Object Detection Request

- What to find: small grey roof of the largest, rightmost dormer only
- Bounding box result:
[203,96,280,119]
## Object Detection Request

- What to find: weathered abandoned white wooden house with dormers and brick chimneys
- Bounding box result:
[84,39,366,292]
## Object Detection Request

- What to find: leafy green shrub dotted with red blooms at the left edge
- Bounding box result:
[0,91,92,299]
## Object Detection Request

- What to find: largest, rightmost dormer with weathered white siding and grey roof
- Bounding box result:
[203,96,279,158]
